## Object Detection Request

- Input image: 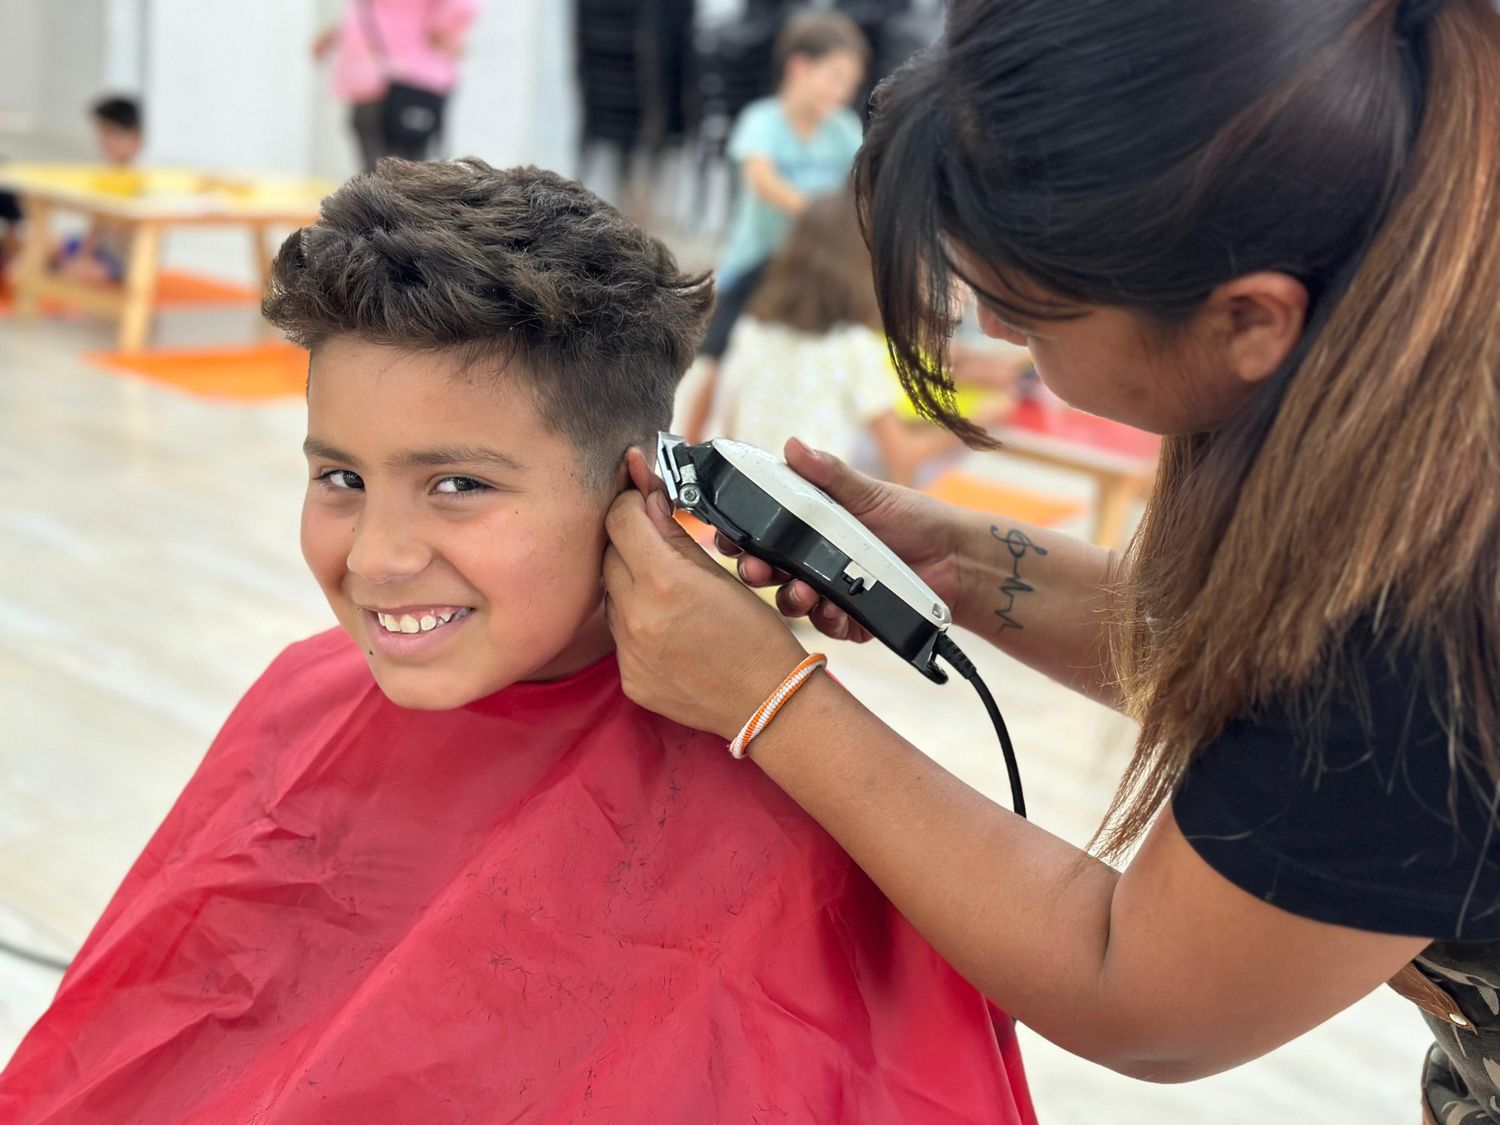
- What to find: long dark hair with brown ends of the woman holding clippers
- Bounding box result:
[857,0,1500,851]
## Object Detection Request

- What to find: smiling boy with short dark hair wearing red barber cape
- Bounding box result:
[0,161,1031,1125]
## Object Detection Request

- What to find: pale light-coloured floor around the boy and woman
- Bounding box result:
[0,288,1425,1125]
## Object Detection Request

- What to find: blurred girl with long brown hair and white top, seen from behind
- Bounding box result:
[707,189,1014,485]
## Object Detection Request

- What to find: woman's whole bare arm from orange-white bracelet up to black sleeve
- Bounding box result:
[750,675,1428,1082]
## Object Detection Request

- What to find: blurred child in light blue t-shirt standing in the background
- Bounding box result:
[701,12,870,366]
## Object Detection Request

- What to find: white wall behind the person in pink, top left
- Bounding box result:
[0,0,579,179]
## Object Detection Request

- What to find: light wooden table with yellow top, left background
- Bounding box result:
[0,164,336,351]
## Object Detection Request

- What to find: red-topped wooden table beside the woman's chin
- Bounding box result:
[995,399,1161,548]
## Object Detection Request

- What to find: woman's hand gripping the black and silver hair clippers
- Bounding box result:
[719,438,965,642]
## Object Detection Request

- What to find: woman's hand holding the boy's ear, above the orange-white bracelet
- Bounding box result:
[605,450,806,741]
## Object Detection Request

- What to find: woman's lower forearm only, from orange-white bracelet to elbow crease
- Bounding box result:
[752,677,1119,1065]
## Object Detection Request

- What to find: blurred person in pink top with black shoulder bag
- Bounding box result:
[312,0,482,171]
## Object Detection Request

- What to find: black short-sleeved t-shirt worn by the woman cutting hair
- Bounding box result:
[1173,630,1500,942]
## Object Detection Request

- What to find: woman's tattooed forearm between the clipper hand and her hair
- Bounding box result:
[954,513,1121,707]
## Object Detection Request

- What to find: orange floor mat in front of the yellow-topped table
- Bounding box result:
[86,341,308,402]
